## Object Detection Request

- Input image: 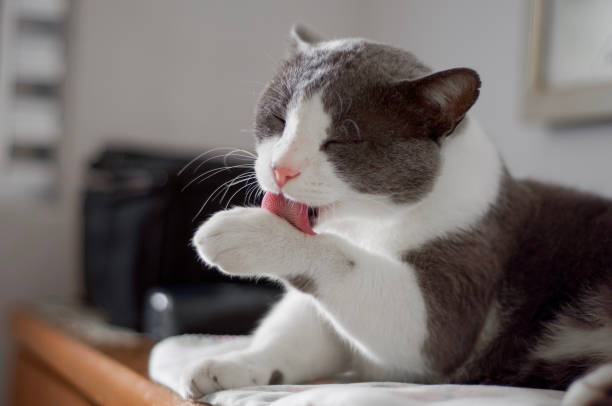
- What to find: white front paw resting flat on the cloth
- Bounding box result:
[178,353,275,399]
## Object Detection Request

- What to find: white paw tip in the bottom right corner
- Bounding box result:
[561,363,612,406]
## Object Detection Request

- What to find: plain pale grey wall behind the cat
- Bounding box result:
[0,0,612,403]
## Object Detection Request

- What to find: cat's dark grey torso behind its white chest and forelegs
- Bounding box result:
[418,174,612,389]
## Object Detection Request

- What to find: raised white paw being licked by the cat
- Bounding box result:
[193,207,308,275]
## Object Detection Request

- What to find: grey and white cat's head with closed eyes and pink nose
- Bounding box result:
[255,26,480,225]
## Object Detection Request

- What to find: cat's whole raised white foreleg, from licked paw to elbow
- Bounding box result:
[194,208,427,379]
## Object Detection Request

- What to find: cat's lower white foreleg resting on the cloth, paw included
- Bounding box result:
[178,291,349,399]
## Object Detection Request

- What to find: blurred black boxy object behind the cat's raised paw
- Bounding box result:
[83,148,280,338]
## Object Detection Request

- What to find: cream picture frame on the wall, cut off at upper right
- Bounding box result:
[524,0,612,123]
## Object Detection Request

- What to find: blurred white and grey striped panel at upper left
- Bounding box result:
[0,0,70,198]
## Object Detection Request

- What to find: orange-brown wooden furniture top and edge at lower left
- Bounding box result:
[11,309,204,406]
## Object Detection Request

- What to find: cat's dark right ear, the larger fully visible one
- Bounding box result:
[410,68,480,137]
